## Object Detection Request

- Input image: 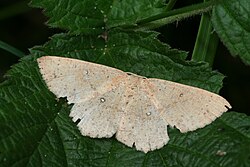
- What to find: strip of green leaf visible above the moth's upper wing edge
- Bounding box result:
[30,30,224,93]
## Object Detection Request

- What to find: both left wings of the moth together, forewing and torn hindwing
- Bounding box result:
[37,56,130,138]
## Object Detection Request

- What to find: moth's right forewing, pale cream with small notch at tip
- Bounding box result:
[148,79,231,132]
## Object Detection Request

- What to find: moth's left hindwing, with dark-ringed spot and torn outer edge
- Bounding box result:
[70,80,127,138]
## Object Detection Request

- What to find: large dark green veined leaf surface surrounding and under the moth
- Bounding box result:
[0,32,250,167]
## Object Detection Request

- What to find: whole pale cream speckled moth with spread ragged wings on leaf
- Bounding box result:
[37,56,231,153]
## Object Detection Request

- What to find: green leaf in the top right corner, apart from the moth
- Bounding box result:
[212,0,250,65]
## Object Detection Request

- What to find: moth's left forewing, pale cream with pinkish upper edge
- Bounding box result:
[37,56,127,103]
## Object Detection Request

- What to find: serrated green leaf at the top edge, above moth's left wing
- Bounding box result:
[31,0,165,34]
